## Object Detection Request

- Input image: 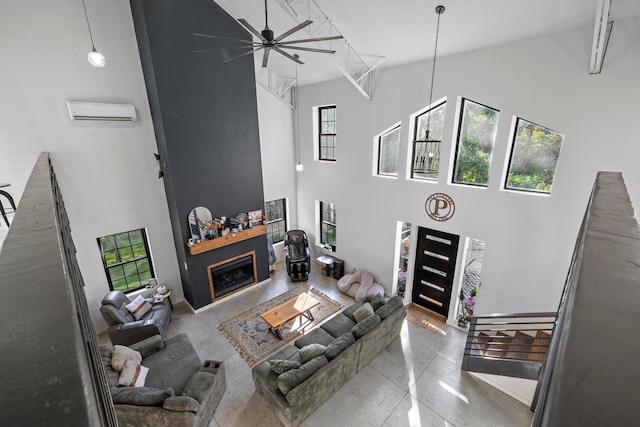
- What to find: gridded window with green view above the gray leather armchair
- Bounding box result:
[98,228,155,292]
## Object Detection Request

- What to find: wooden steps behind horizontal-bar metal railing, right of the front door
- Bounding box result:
[462,312,557,380]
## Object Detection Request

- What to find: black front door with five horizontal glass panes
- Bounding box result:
[411,227,460,317]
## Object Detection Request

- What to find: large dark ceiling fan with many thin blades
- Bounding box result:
[193,0,342,67]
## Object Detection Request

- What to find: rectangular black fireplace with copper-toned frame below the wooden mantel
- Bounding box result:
[207,251,258,300]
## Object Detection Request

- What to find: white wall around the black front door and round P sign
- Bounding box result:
[298,18,640,317]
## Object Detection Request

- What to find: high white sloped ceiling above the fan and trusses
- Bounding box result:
[215,0,640,85]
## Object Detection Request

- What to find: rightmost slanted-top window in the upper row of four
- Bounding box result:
[505,118,564,194]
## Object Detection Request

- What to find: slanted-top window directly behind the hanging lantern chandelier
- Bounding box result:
[411,102,446,180]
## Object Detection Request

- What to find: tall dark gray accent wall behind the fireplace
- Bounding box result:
[131,0,269,308]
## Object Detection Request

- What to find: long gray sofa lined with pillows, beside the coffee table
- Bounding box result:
[252,295,407,426]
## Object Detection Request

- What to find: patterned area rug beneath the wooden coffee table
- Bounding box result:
[218,285,343,367]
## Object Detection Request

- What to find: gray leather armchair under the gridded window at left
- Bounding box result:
[100,291,171,346]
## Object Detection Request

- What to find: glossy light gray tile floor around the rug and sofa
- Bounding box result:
[101,264,532,427]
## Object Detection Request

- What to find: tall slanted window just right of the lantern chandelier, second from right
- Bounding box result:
[452,99,500,187]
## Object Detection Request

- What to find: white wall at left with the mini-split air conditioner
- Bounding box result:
[0,0,186,330]
